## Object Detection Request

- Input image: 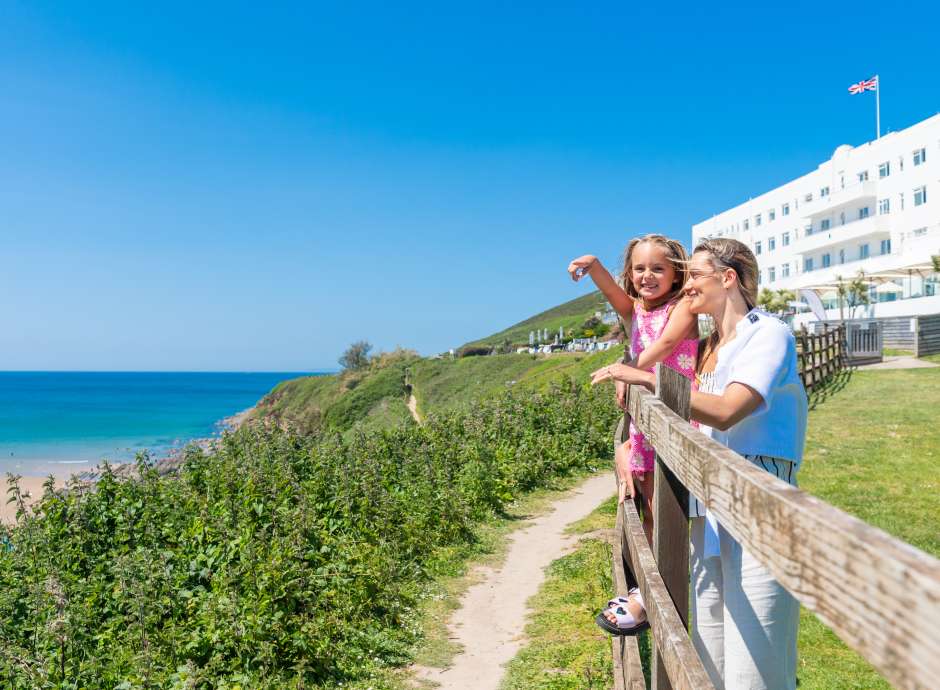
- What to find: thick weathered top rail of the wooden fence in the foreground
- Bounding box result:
[628,386,940,689]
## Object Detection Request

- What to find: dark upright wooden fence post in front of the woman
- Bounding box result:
[652,364,692,690]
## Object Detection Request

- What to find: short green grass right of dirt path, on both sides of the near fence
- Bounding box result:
[505,366,940,690]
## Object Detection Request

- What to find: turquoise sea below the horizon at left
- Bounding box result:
[0,371,316,476]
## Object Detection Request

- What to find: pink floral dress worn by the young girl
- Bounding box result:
[630,300,698,474]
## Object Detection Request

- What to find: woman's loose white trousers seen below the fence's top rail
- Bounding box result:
[689,460,800,690]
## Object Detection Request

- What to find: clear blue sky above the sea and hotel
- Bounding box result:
[0,2,940,371]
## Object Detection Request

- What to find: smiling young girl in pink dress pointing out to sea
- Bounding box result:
[568,235,698,634]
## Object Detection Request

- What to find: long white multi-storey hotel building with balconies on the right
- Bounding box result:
[692,114,940,320]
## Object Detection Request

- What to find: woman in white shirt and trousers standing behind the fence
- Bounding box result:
[592,238,807,690]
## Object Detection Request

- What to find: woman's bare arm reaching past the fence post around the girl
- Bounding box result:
[591,364,764,431]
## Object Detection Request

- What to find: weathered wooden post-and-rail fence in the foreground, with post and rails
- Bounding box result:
[612,366,940,690]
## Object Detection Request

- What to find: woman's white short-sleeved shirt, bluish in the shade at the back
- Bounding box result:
[708,309,808,469]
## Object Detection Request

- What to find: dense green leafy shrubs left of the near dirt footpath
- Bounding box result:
[0,382,618,690]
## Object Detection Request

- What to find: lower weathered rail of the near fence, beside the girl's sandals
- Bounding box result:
[622,494,714,690]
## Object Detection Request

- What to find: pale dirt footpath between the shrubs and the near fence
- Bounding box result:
[416,472,615,690]
